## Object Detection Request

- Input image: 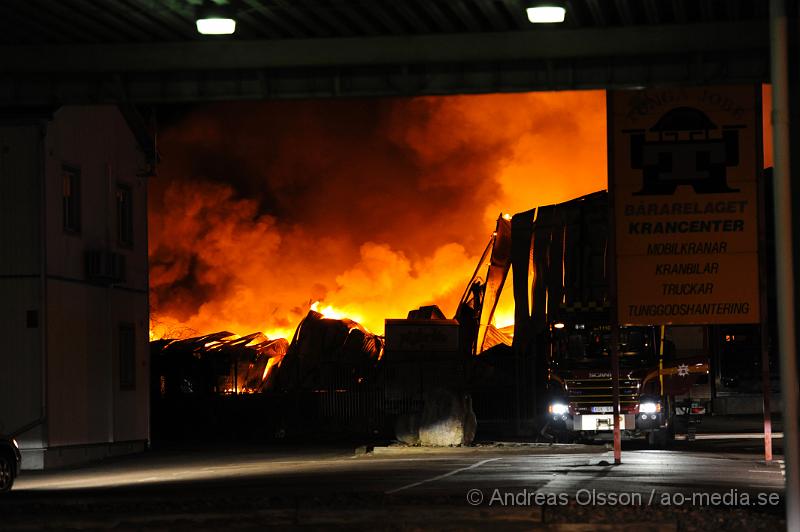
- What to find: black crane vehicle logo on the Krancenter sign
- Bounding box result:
[623,107,745,196]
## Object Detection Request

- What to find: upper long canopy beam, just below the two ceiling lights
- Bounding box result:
[0,21,769,73]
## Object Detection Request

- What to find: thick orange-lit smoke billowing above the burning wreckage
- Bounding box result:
[150,92,606,336]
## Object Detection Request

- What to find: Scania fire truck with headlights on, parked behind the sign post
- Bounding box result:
[546,320,711,447]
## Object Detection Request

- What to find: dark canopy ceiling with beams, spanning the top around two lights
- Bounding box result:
[0,0,788,106]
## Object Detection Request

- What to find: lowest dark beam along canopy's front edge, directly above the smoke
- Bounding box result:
[0,51,769,108]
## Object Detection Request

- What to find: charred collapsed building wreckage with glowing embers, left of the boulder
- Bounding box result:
[151,310,385,440]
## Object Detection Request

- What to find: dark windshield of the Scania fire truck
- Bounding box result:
[552,326,656,367]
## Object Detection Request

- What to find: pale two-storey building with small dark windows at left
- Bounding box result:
[0,106,151,469]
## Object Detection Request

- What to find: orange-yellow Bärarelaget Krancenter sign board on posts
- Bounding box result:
[608,85,762,325]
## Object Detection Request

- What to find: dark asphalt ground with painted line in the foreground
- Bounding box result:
[0,442,784,530]
